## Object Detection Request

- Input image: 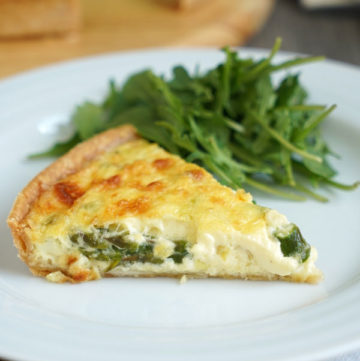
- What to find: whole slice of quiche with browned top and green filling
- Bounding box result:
[8,126,321,283]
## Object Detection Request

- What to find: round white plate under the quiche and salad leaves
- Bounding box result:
[0,49,360,361]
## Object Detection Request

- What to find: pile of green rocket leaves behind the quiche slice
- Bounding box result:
[30,39,359,201]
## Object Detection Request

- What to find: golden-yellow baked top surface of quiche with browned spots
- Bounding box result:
[27,140,266,242]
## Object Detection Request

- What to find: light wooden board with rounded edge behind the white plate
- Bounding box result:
[0,0,275,78]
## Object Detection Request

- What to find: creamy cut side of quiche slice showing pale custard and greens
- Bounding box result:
[35,209,318,281]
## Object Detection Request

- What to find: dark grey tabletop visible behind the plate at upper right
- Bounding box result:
[0,0,360,361]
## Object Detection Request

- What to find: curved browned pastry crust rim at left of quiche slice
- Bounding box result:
[7,125,139,276]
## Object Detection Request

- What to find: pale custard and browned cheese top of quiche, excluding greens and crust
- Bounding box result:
[27,140,320,280]
